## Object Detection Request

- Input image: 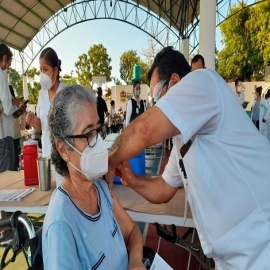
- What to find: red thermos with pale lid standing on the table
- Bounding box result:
[23,141,38,186]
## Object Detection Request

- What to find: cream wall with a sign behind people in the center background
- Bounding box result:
[107,84,150,111]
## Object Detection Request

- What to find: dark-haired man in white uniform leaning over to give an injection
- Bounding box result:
[106,47,270,270]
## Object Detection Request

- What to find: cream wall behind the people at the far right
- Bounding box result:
[228,81,270,111]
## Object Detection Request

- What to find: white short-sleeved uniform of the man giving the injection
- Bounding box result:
[156,69,270,270]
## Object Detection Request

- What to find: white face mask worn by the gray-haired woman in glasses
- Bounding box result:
[66,135,108,181]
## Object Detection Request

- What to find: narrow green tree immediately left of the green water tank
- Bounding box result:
[119,50,141,84]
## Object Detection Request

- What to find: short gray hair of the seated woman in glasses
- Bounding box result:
[48,85,96,176]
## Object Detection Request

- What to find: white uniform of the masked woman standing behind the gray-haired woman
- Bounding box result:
[37,82,65,158]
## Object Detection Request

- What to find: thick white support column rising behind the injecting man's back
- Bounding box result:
[199,0,216,70]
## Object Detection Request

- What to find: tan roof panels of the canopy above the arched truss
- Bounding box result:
[0,0,199,51]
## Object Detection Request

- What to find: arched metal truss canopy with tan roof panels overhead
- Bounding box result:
[0,0,266,69]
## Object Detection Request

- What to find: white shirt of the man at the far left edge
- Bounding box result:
[0,68,18,139]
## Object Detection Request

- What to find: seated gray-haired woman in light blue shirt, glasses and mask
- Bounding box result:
[42,85,145,270]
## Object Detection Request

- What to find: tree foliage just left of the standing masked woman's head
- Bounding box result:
[25,68,41,104]
